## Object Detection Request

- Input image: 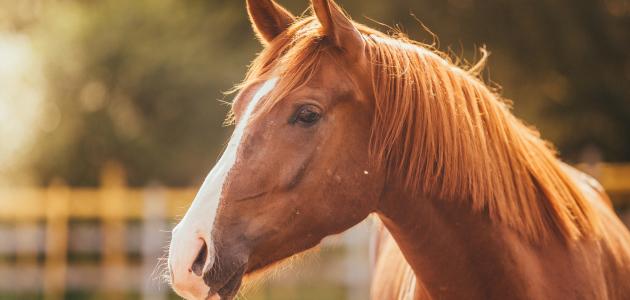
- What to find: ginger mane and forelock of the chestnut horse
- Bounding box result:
[235,17,597,241]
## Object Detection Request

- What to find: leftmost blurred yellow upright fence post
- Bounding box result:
[44,180,70,300]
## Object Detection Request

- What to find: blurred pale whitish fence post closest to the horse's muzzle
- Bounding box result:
[141,184,168,300]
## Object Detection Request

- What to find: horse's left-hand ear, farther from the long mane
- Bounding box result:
[247,0,295,45]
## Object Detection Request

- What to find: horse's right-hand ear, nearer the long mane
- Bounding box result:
[311,0,365,56]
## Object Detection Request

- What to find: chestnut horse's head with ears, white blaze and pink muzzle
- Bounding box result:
[168,0,383,299]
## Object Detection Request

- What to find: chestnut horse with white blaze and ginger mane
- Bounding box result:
[168,0,630,299]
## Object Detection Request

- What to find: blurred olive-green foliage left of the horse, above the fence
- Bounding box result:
[31,0,258,185]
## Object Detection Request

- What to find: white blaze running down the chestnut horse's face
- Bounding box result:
[169,78,278,273]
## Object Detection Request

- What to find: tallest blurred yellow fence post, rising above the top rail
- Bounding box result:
[100,162,128,298]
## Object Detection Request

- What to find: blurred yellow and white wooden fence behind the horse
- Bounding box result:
[0,164,630,299]
